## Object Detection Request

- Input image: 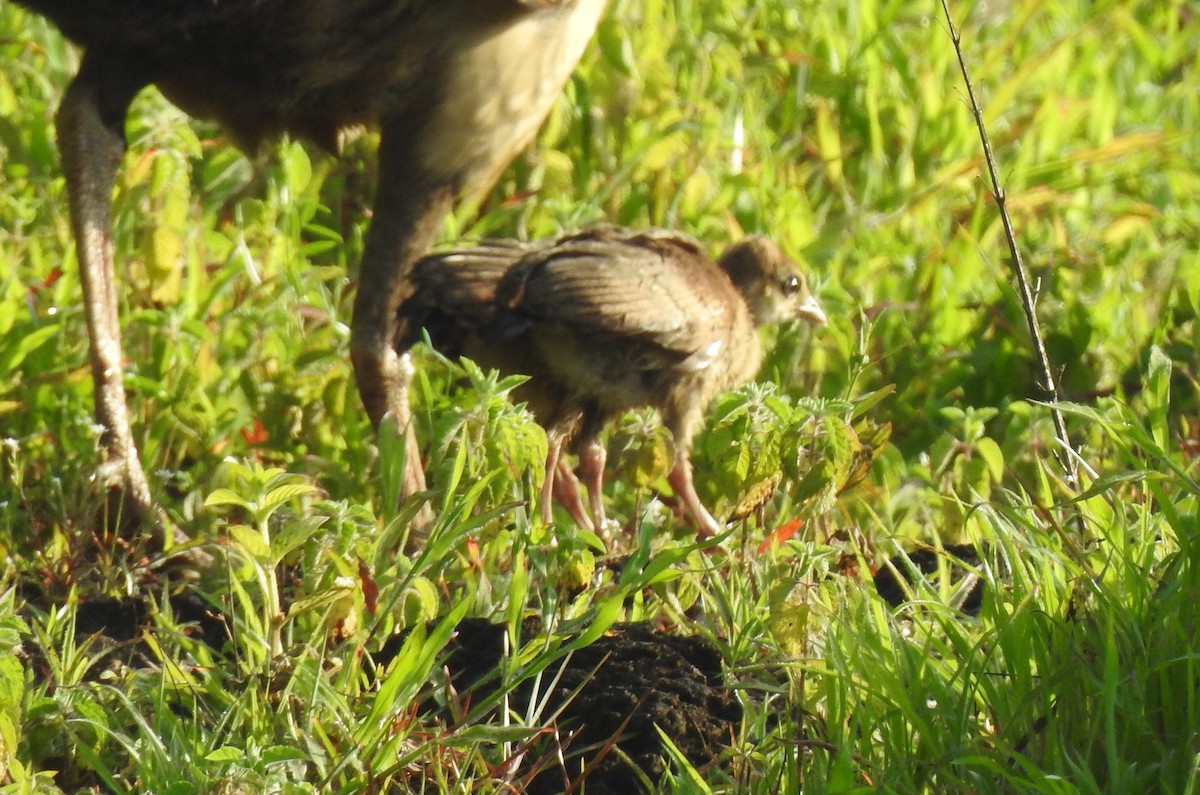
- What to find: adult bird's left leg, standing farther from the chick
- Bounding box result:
[56,50,164,544]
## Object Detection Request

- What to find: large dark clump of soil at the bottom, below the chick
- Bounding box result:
[383,620,742,795]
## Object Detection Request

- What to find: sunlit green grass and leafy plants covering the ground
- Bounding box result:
[0,0,1200,795]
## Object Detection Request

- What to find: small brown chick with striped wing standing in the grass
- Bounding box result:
[401,227,826,537]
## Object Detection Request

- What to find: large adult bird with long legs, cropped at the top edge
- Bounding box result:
[20,0,605,547]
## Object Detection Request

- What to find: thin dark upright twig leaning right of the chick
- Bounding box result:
[942,0,1079,489]
